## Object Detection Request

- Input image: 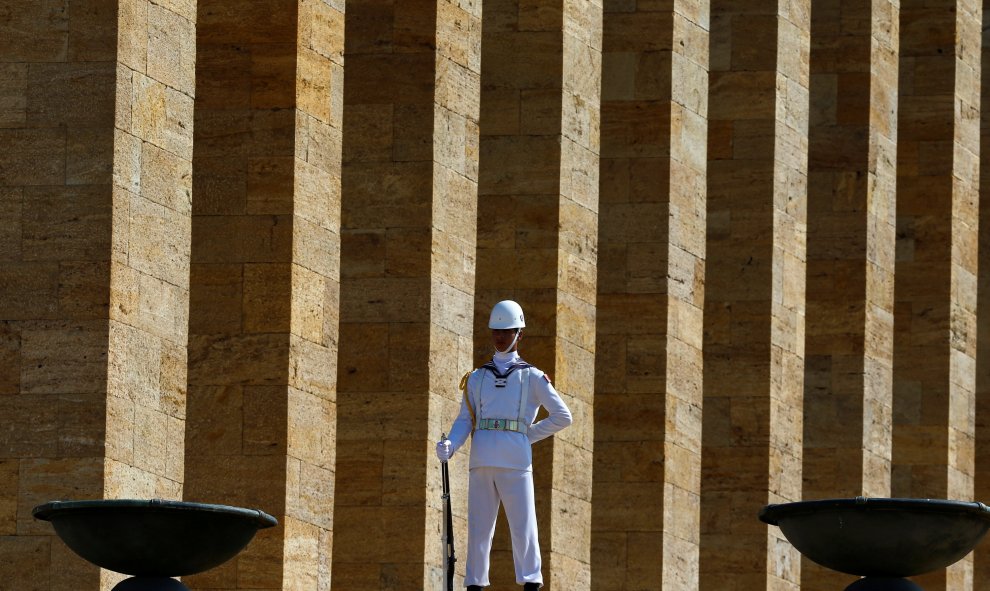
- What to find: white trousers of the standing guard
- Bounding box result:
[464,468,543,587]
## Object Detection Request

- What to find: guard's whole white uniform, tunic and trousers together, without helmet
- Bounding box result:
[449,351,571,587]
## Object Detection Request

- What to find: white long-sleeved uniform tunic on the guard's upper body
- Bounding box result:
[449,351,572,471]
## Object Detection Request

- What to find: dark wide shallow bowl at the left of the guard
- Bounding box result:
[32,499,278,577]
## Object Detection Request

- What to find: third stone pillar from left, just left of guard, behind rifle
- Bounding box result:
[333,0,481,589]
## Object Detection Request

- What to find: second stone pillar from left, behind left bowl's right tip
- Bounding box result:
[186,0,344,590]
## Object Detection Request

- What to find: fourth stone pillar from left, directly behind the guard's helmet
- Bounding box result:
[475,0,602,589]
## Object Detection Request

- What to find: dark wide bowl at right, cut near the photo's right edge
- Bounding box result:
[760,497,990,577]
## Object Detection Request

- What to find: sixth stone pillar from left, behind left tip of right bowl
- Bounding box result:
[700,0,811,591]
